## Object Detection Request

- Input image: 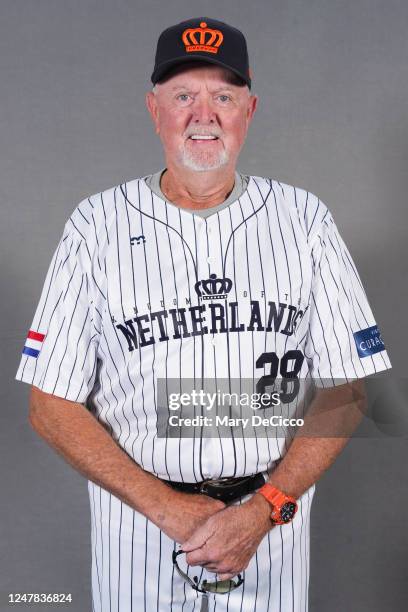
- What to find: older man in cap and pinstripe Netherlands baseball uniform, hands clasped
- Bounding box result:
[16,18,390,612]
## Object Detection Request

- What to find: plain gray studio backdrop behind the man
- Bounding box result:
[0,0,408,612]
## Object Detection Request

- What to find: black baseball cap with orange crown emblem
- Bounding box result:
[151,17,252,88]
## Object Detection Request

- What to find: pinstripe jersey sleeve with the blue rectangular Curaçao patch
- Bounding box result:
[305,209,391,386]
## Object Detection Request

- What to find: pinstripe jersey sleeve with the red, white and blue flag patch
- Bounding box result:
[15,220,100,403]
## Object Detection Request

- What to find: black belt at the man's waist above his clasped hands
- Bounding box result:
[163,472,266,502]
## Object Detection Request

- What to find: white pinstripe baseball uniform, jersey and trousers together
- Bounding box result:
[16,176,391,612]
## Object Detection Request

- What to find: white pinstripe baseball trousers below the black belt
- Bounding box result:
[88,482,315,612]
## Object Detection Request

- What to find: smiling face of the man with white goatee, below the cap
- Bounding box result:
[146,65,258,172]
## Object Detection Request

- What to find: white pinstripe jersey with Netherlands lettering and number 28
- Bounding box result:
[16,176,391,482]
